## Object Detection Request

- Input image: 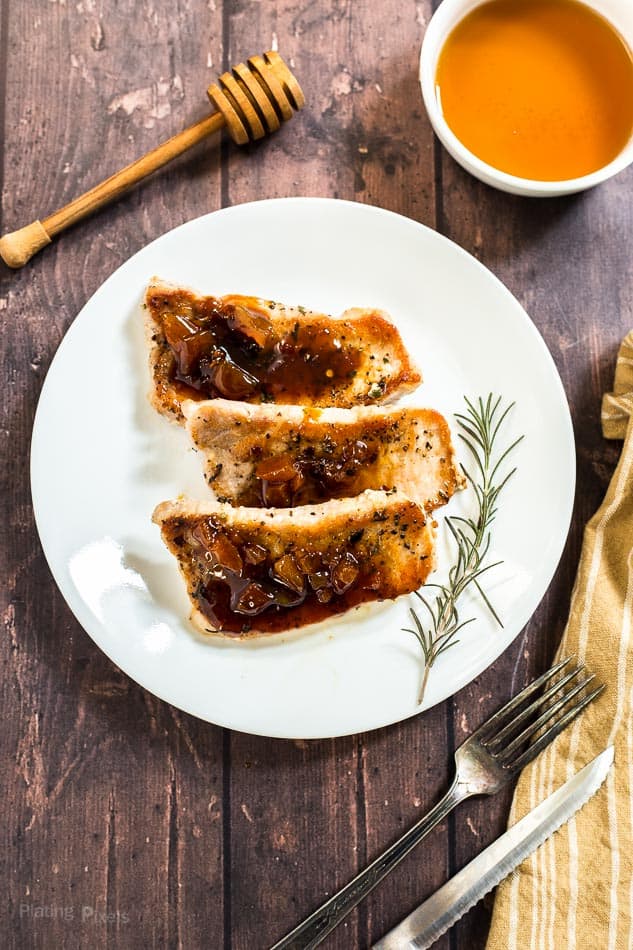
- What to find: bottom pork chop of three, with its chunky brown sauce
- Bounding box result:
[153,491,435,636]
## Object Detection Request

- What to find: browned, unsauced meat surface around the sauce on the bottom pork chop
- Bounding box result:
[153,491,435,637]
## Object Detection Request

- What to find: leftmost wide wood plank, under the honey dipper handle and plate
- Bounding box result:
[0,2,224,948]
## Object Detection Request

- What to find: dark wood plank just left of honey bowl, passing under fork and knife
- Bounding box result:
[342,2,452,950]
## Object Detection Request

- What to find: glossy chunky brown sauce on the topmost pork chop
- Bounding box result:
[149,291,361,402]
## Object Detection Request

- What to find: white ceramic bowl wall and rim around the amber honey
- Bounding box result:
[420,0,633,198]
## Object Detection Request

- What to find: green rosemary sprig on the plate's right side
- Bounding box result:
[405,393,523,703]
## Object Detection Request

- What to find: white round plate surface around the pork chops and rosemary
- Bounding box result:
[31,198,575,738]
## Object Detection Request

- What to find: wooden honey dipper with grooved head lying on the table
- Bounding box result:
[0,50,305,267]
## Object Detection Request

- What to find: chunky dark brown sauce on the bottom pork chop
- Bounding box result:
[174,518,380,634]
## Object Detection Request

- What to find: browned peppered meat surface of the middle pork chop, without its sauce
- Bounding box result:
[183,399,464,511]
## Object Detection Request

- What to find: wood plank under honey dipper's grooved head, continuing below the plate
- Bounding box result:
[224,2,365,950]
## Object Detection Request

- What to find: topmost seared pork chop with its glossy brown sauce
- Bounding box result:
[145,278,421,422]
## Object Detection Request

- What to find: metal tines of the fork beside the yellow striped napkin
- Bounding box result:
[478,656,605,771]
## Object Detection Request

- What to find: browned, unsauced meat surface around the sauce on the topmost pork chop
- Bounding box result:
[144,277,422,423]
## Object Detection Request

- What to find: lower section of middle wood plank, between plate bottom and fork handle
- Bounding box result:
[230,734,365,950]
